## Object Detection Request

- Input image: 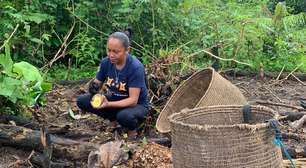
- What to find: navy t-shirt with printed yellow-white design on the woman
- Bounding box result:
[96,55,148,107]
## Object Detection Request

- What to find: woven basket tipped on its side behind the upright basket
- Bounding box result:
[156,68,247,133]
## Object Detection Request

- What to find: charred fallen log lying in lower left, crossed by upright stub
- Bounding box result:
[0,124,99,160]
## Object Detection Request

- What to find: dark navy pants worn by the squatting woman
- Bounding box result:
[77,94,148,130]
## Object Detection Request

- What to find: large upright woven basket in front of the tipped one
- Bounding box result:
[169,106,282,168]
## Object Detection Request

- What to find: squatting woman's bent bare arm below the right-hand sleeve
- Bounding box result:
[101,88,140,108]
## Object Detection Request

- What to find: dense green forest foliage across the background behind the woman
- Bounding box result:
[0,0,306,76]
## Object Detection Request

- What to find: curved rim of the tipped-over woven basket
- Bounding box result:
[156,67,215,133]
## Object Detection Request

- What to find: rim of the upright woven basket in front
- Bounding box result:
[168,105,280,131]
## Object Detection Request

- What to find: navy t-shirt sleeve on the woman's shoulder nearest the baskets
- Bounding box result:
[128,67,145,88]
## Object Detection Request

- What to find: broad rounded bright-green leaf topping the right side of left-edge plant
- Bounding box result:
[13,61,43,81]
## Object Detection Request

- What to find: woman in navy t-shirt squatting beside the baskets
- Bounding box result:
[77,32,148,138]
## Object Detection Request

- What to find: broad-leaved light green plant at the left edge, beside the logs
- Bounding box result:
[0,45,51,115]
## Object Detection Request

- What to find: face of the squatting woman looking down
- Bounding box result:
[107,38,129,64]
